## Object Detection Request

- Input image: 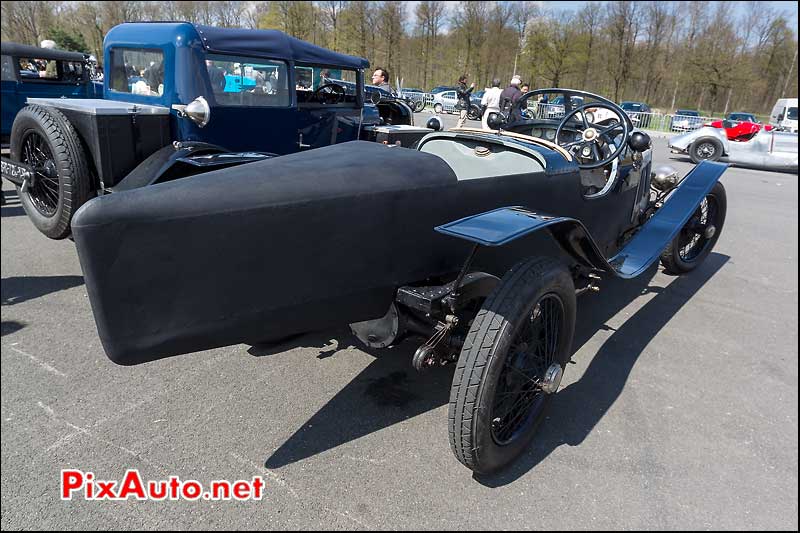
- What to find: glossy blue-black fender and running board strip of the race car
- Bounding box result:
[435,161,728,279]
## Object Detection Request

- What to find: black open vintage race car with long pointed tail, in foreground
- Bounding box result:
[72,89,727,472]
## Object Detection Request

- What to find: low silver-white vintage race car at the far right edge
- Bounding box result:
[669,126,797,172]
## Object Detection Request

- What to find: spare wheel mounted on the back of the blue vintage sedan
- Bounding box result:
[11,105,91,239]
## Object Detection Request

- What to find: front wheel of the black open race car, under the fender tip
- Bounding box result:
[661,182,728,275]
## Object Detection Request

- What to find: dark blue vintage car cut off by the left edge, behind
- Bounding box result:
[0,41,103,145]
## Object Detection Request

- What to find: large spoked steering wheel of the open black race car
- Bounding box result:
[556,102,630,169]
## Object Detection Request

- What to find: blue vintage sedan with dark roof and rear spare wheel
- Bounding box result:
[3,22,419,239]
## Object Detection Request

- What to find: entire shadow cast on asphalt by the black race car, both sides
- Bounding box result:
[264,253,729,470]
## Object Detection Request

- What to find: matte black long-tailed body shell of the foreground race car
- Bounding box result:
[72,141,629,364]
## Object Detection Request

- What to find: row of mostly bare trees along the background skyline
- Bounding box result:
[0,0,798,114]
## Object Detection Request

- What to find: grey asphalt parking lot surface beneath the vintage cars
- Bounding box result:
[0,118,798,530]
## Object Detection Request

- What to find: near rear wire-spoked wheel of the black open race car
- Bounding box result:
[448,257,575,473]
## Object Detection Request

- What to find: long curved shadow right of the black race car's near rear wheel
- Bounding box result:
[473,253,730,487]
